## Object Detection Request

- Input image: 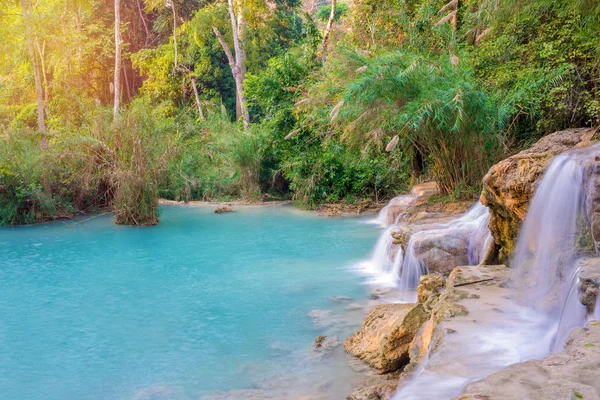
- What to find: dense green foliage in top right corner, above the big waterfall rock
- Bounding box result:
[473,0,600,139]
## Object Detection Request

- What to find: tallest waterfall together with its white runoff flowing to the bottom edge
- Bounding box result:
[393,145,600,400]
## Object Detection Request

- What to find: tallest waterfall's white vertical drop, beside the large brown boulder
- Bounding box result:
[513,146,600,351]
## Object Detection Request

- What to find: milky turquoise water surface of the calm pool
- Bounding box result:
[0,206,378,400]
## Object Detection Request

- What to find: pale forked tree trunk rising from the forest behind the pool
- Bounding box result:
[213,0,250,128]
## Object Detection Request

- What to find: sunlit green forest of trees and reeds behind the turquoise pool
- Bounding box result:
[0,0,600,225]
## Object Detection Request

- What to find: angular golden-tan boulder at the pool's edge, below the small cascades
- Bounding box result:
[344,304,429,374]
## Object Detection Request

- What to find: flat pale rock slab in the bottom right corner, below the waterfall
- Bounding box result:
[456,322,600,400]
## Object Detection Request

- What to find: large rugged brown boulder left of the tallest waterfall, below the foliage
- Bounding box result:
[481,128,600,262]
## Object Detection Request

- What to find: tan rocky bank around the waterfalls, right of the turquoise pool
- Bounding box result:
[344,129,600,400]
